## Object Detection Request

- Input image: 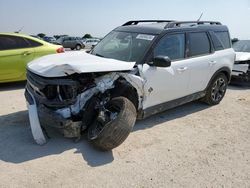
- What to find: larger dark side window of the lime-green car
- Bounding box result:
[0,35,29,50]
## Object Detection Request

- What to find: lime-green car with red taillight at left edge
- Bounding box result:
[0,33,64,83]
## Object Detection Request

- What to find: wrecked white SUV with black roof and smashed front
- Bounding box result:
[25,20,235,150]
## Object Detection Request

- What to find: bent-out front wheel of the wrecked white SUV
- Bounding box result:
[88,97,136,150]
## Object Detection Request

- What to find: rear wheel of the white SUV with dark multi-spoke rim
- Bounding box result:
[202,73,228,105]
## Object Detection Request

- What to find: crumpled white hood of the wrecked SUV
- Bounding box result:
[27,51,135,77]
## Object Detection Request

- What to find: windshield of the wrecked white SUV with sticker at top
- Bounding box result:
[92,31,155,62]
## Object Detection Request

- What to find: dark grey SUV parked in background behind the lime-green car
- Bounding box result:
[55,36,85,50]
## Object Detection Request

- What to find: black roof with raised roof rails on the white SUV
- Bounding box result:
[115,20,228,35]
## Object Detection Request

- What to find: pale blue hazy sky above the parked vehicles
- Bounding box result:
[0,0,250,39]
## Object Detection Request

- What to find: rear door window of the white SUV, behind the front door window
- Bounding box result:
[188,32,211,57]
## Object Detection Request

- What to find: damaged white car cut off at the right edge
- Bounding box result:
[232,40,250,83]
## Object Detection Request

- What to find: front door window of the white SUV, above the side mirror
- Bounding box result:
[154,34,185,60]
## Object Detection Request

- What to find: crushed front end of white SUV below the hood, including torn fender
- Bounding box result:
[25,70,143,144]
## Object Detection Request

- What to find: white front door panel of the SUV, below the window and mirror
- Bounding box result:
[142,60,192,109]
